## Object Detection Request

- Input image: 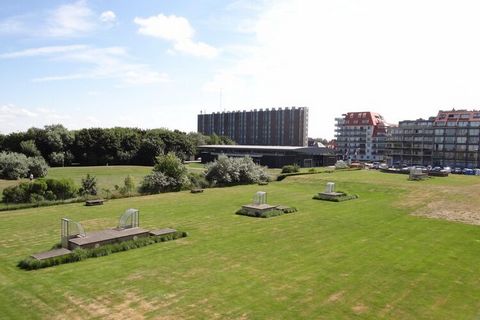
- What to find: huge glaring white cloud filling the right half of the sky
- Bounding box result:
[204,0,480,137]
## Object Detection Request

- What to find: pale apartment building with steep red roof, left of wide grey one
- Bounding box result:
[335,112,388,161]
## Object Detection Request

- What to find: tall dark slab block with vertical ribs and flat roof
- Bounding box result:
[197,107,308,146]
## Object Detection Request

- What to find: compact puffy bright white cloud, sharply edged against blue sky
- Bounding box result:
[134,14,218,58]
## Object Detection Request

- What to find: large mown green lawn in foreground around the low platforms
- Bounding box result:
[0,170,480,319]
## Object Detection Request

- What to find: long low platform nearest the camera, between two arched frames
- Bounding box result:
[68,228,149,250]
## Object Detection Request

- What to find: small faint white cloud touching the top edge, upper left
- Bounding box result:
[47,0,95,37]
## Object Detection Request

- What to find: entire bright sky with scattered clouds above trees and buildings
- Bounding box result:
[0,0,480,138]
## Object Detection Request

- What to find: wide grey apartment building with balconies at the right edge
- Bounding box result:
[386,109,480,168]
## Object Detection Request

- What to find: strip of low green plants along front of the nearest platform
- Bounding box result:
[17,231,188,270]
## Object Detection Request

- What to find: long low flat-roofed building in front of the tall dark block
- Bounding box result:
[198,145,336,168]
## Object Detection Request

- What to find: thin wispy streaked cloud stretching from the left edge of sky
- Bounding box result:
[0,45,169,85]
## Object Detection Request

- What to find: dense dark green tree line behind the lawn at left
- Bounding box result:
[0,124,235,166]
